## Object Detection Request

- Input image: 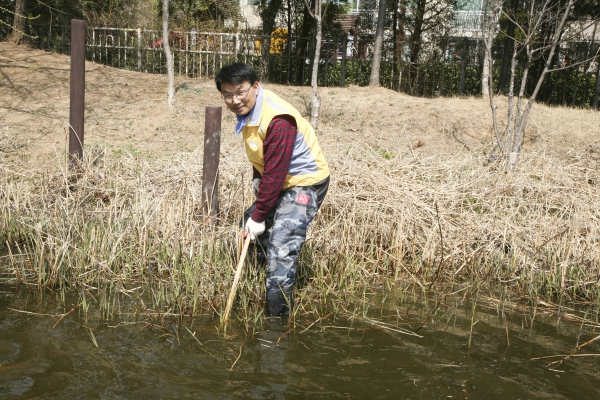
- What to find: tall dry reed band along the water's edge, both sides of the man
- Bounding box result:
[0,139,600,321]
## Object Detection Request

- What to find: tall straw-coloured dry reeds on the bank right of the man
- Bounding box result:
[312,141,600,299]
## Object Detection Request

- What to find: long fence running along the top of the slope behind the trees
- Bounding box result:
[0,21,600,109]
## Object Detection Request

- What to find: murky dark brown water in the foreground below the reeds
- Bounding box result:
[0,285,600,399]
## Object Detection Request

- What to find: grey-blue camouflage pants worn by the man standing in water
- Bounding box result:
[244,186,322,294]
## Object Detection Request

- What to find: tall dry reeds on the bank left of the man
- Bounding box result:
[0,145,253,313]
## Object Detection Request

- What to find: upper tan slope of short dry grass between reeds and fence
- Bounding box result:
[0,43,600,167]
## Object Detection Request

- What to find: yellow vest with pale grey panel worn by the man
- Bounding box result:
[236,86,329,190]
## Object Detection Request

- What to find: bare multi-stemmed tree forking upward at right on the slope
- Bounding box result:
[486,0,576,171]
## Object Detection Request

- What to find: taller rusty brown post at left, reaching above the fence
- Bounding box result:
[69,19,85,167]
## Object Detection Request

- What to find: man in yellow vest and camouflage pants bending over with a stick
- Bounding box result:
[215,62,329,317]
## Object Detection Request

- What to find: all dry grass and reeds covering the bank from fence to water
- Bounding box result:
[0,44,600,322]
